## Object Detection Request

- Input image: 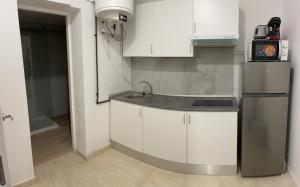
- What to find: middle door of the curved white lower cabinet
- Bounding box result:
[143,107,187,163]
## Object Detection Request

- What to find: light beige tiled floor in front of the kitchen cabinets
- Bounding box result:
[27,149,293,187]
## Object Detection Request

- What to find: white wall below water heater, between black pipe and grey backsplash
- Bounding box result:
[98,20,132,101]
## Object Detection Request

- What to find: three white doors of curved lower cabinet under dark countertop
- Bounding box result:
[111,100,237,166]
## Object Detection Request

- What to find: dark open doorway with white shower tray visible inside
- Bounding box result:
[18,10,73,165]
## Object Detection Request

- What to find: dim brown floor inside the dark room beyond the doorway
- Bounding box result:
[31,114,73,166]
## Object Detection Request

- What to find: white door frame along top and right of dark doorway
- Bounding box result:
[18,4,78,151]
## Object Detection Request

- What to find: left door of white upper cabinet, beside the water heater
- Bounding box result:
[123,0,154,57]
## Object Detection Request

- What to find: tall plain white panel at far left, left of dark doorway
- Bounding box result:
[0,0,34,185]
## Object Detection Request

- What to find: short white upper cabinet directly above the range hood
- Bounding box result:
[193,0,239,46]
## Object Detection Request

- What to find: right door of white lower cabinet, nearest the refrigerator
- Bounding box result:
[188,112,237,165]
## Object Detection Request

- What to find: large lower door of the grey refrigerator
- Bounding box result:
[241,96,288,177]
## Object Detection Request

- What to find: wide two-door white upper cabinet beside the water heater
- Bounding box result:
[123,0,193,57]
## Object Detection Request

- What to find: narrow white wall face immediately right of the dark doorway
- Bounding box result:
[68,0,86,154]
